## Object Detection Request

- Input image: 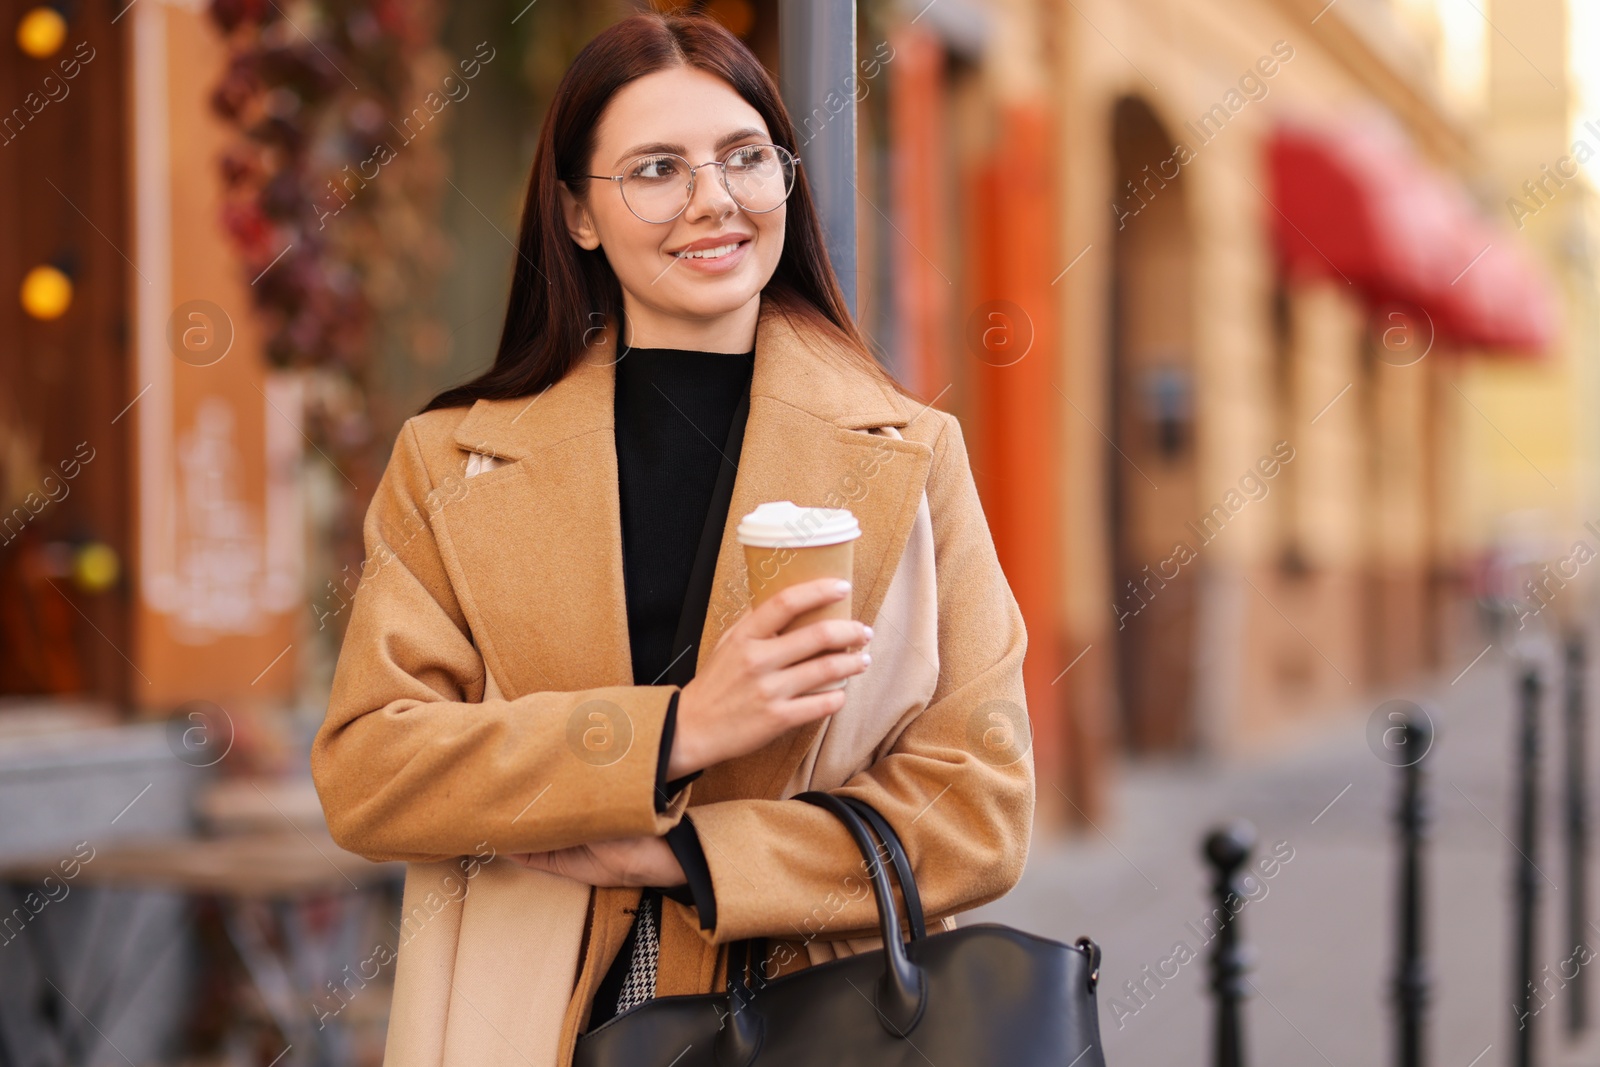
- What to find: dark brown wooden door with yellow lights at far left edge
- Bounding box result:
[0,0,136,702]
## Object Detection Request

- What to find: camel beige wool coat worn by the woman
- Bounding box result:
[312,294,1034,1067]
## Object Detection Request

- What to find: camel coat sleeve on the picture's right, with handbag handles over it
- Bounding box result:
[690,413,1034,944]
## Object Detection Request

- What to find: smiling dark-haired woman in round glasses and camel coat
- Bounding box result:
[312,14,1034,1067]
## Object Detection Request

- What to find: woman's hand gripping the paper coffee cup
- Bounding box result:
[667,577,872,779]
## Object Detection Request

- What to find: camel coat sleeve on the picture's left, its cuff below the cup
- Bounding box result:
[310,412,690,862]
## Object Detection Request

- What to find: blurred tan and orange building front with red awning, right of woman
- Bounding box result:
[862,0,1595,817]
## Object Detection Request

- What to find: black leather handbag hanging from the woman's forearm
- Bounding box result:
[573,790,1106,1067]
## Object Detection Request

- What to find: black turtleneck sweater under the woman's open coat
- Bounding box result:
[589,349,755,1029]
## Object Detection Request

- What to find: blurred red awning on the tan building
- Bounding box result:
[1267,122,1558,354]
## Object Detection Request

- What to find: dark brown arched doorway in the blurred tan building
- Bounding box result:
[1106,98,1205,752]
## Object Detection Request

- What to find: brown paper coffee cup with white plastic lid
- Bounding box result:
[736,501,861,696]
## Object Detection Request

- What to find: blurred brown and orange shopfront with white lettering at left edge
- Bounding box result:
[0,3,306,735]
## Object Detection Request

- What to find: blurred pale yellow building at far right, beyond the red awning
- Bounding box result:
[1454,0,1600,614]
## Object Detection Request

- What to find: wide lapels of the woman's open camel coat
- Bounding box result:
[438,299,933,801]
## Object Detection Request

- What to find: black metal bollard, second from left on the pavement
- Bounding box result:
[1394,715,1434,1067]
